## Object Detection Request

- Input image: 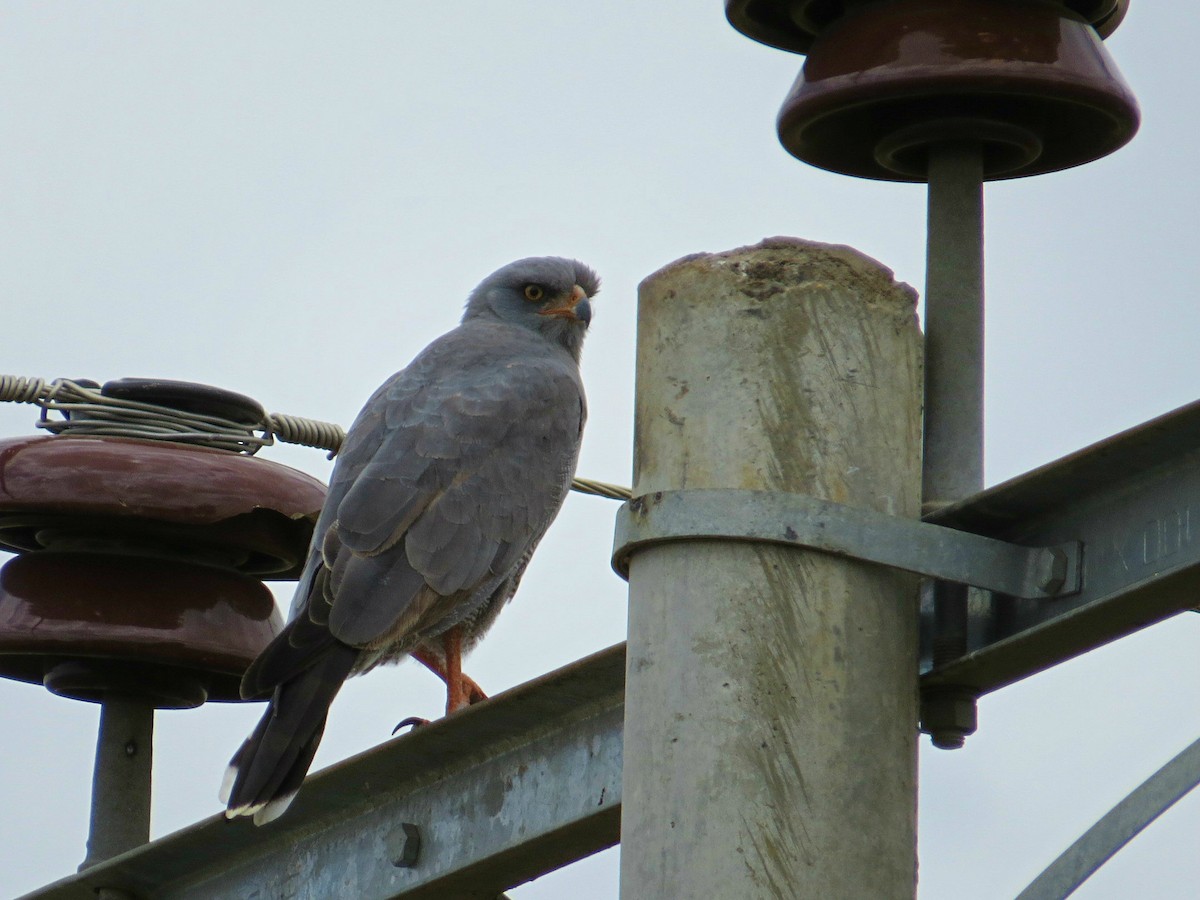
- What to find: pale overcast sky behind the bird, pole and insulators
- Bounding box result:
[0,0,1200,900]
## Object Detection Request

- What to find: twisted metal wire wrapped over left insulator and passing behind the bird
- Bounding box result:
[0,374,631,500]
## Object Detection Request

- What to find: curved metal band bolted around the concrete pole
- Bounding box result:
[612,490,1081,600]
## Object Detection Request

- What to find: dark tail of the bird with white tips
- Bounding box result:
[221,644,359,824]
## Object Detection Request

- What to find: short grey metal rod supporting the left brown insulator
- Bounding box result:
[79,694,154,871]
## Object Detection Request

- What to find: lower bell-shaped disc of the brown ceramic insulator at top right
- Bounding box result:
[778,0,1139,181]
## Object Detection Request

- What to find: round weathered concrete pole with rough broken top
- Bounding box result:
[620,239,922,900]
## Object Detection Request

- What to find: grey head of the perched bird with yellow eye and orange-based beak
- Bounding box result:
[462,257,600,359]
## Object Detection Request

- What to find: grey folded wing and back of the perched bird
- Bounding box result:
[318,331,583,647]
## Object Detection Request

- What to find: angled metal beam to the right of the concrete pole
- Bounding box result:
[922,402,1200,692]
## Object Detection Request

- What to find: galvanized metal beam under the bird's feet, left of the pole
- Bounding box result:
[18,644,625,900]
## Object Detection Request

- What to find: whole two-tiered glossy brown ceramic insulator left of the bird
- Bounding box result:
[0,437,325,707]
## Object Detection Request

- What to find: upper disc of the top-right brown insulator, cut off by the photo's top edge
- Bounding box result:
[725,0,1129,53]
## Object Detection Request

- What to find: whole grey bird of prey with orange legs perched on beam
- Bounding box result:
[221,257,600,824]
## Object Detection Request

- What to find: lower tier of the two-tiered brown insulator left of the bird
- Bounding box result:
[0,551,282,708]
